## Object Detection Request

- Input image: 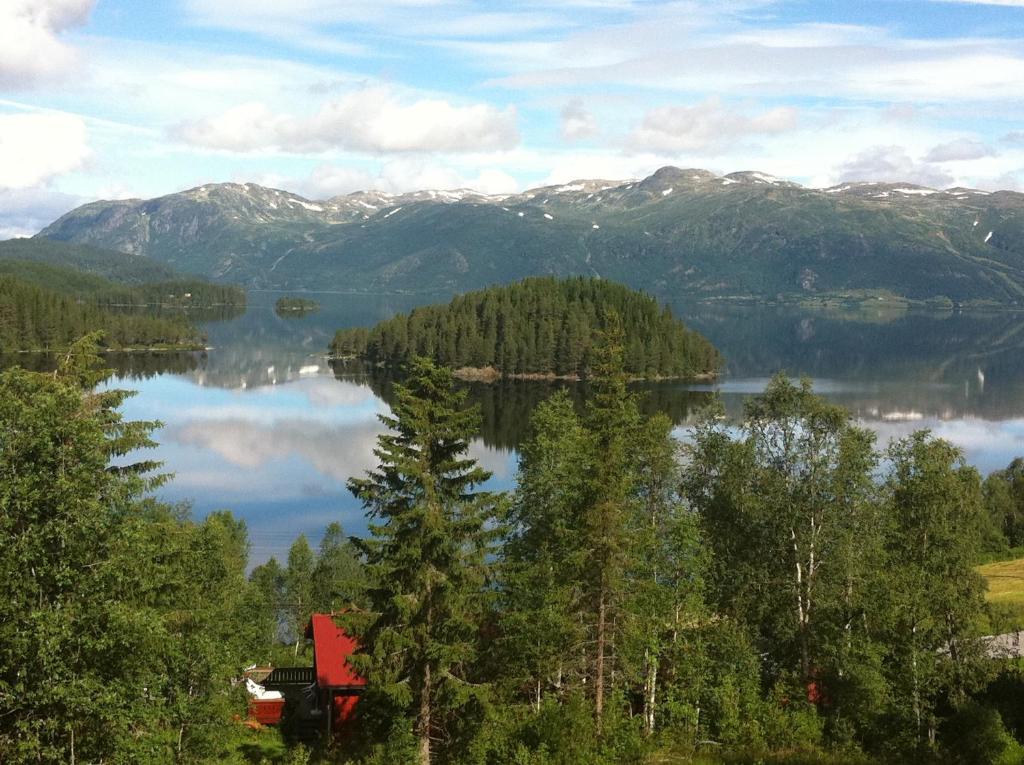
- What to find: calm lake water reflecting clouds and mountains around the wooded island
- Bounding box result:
[25,293,1024,562]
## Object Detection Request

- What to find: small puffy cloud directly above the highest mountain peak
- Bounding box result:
[629,97,797,153]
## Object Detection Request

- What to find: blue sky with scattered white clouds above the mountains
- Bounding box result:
[0,0,1024,239]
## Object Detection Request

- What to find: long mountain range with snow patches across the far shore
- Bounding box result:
[29,167,1024,304]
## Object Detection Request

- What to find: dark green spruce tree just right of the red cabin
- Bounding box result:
[348,358,498,765]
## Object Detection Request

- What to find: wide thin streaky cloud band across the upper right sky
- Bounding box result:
[481,14,1024,102]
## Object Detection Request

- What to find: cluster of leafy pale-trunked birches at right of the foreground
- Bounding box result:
[686,377,989,757]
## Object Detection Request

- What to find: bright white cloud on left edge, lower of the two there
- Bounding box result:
[0,112,89,189]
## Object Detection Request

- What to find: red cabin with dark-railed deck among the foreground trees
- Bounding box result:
[242,613,367,736]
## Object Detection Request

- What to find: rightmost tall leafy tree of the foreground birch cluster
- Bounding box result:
[880,431,986,741]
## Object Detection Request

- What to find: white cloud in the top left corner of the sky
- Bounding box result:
[0,0,94,88]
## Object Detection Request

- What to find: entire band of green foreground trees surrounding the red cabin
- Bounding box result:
[9,325,1024,765]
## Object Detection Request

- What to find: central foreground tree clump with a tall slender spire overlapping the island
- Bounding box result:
[493,313,705,761]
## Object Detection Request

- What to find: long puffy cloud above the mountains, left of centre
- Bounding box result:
[173,86,519,154]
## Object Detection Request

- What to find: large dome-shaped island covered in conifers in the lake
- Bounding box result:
[331,277,722,380]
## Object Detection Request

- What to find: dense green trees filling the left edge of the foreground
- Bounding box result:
[0,338,258,763]
